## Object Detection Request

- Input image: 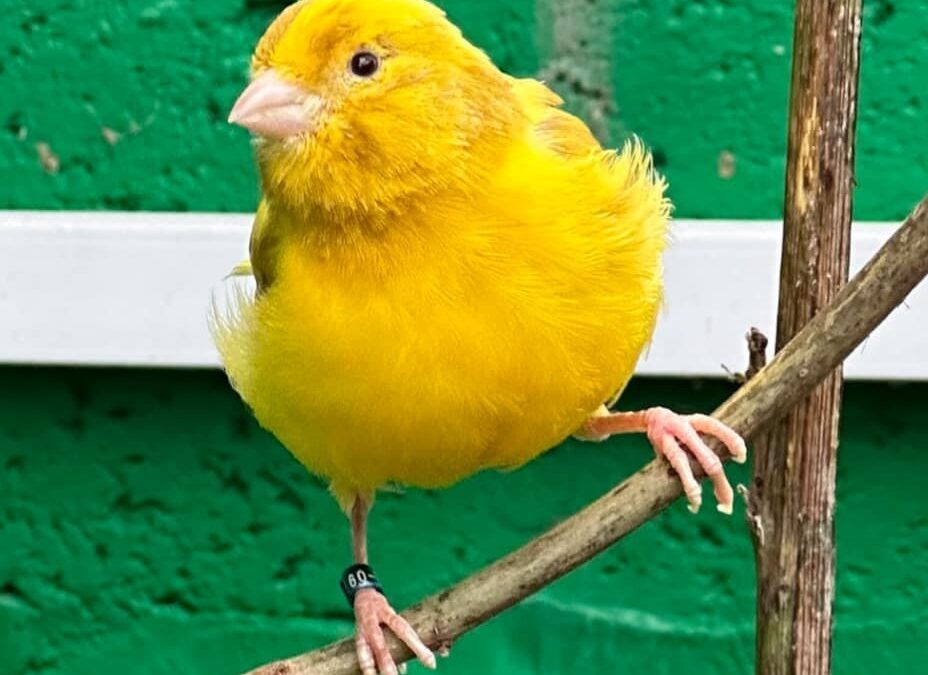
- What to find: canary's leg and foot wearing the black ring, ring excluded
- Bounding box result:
[351,496,435,675]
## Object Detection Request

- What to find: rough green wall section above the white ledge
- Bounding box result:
[0,0,928,219]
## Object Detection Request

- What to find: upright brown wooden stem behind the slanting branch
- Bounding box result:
[750,0,861,675]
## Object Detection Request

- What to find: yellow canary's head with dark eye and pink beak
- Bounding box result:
[229,0,516,208]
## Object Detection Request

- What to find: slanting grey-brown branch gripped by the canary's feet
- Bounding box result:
[249,196,928,675]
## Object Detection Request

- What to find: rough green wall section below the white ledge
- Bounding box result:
[0,368,928,675]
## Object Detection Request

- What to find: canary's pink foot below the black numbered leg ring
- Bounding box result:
[354,588,435,675]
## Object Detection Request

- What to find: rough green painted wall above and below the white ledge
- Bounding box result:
[0,0,928,675]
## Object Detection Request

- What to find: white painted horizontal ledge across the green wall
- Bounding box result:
[0,211,928,380]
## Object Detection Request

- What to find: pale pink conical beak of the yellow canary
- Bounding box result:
[229,70,322,138]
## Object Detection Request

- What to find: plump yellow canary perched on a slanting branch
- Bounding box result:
[214,0,744,673]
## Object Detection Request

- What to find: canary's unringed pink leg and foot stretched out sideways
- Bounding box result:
[578,408,747,514]
